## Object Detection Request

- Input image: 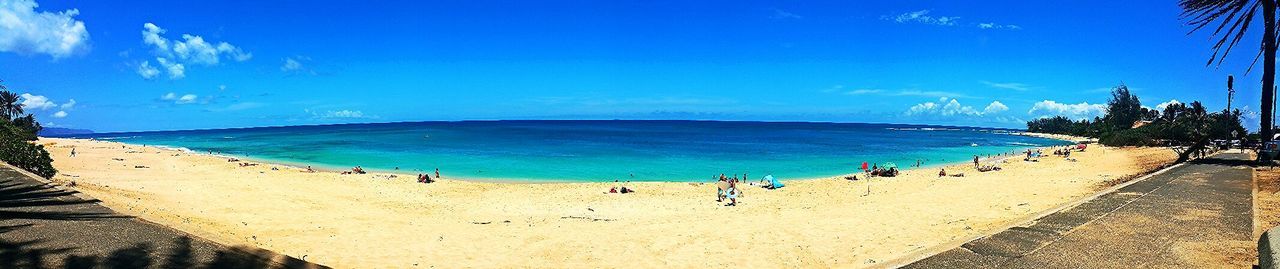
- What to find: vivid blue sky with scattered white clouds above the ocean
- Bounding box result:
[0,0,1261,132]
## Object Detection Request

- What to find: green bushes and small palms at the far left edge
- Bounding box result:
[0,81,58,178]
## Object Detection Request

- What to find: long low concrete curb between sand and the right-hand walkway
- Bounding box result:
[872,152,1187,269]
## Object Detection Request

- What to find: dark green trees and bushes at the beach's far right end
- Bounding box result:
[1027,85,1248,161]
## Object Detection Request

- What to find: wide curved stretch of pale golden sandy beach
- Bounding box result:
[38,138,1175,268]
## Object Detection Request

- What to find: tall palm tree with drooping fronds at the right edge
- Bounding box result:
[1178,0,1276,142]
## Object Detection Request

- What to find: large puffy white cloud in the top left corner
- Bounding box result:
[0,0,88,59]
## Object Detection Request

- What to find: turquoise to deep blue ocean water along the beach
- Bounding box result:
[77,120,1068,182]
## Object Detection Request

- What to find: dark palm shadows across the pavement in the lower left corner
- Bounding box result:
[0,178,325,269]
